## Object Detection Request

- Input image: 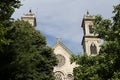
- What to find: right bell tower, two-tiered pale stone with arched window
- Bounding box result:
[81,12,100,56]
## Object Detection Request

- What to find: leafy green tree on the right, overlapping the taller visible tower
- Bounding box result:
[74,4,120,80]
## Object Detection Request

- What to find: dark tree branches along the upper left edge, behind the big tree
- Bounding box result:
[0,0,21,51]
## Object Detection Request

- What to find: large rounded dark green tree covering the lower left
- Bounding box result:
[0,20,57,80]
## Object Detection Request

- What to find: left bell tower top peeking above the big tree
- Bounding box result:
[21,10,36,27]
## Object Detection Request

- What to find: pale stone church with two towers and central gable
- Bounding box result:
[21,10,100,80]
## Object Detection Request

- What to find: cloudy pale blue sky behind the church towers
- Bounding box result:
[12,0,120,54]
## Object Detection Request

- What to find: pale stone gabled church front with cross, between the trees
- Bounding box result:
[52,39,77,80]
